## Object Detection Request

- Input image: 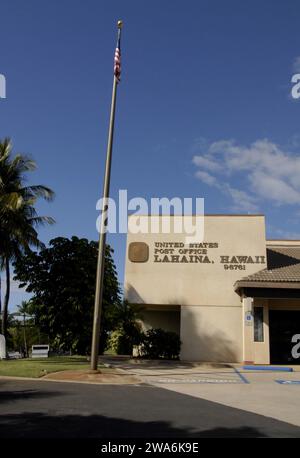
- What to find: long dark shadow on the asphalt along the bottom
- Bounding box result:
[0,412,266,439]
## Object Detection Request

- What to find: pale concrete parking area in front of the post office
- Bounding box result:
[102,360,300,426]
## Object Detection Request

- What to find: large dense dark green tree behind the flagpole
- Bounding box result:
[15,237,120,354]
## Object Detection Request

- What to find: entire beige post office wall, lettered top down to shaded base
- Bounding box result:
[124,215,266,362]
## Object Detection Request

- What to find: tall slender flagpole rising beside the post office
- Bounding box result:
[91,21,122,371]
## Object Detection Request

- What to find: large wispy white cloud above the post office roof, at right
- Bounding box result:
[193,139,300,211]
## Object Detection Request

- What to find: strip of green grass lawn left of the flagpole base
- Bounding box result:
[0,356,95,378]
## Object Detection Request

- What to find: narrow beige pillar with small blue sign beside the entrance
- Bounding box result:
[242,297,254,364]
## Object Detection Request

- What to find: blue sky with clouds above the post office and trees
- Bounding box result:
[0,0,300,305]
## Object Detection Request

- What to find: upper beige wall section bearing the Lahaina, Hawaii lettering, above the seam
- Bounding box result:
[125,216,266,307]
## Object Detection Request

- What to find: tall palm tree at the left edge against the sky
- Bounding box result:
[0,138,54,336]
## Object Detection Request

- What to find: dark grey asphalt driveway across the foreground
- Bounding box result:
[0,372,300,438]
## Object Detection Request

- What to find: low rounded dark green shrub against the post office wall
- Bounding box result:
[141,329,181,359]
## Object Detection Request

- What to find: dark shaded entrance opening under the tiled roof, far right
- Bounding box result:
[269,310,300,364]
